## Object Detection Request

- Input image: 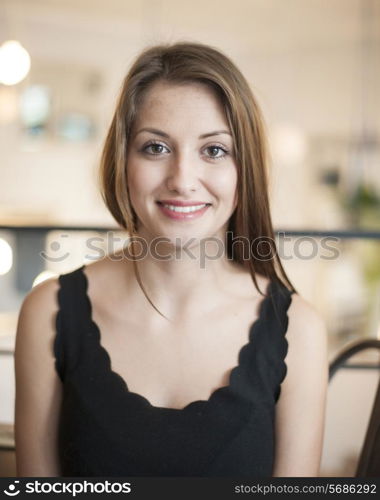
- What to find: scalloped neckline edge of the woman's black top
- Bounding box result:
[79,264,274,413]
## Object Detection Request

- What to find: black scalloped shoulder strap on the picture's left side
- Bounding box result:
[54,266,86,382]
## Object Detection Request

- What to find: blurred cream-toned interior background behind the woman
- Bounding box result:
[0,0,380,476]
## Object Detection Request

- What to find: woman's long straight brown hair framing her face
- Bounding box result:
[99,41,297,320]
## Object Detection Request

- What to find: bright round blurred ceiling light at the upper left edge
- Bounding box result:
[0,40,30,85]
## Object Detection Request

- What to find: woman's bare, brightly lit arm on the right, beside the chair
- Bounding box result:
[273,294,328,477]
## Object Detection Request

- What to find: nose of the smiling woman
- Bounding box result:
[166,154,199,195]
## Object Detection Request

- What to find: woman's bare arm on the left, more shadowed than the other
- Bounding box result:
[15,278,62,476]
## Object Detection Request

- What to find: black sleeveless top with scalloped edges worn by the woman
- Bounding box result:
[54,266,292,478]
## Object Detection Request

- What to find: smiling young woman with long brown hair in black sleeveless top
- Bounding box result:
[15,42,328,478]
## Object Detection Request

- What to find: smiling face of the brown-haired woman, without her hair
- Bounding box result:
[127,82,237,247]
